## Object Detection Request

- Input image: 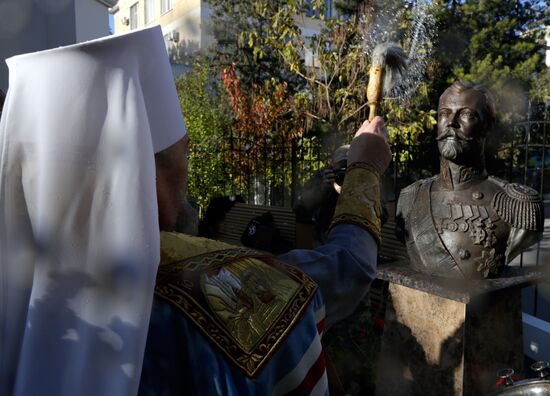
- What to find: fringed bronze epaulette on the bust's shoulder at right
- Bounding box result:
[489,177,544,231]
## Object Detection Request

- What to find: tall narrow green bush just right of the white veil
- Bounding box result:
[176,58,234,208]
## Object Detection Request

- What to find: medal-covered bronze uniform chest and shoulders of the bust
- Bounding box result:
[398,169,543,278]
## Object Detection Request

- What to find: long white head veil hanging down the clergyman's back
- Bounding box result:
[0,27,185,396]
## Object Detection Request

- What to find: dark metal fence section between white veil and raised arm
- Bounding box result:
[189,136,332,209]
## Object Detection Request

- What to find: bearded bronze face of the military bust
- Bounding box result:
[437,89,486,165]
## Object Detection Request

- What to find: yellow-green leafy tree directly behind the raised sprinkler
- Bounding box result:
[256,0,442,166]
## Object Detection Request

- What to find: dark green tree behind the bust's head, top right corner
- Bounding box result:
[433,0,549,118]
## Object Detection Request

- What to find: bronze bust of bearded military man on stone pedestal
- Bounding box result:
[396,81,544,278]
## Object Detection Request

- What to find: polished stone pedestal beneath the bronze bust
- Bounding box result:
[376,265,543,396]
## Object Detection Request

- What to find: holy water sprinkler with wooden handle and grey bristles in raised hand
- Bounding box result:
[367,43,407,121]
